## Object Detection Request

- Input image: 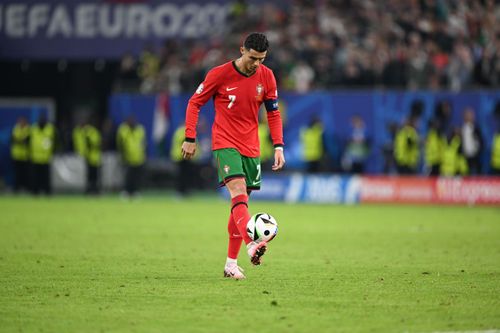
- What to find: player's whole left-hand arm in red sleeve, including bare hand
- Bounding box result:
[181,69,217,160]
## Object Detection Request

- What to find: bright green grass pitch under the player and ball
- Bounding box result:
[0,196,500,333]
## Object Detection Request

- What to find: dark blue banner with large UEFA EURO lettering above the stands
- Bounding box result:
[0,0,286,59]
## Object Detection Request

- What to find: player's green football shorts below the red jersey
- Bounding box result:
[213,148,261,190]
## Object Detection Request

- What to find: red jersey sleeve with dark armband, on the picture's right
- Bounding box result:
[264,70,284,147]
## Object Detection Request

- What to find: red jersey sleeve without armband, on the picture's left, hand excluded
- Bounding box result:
[185,69,218,142]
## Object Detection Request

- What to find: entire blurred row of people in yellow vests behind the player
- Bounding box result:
[6,100,500,197]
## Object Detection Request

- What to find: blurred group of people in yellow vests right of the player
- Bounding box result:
[300,100,500,177]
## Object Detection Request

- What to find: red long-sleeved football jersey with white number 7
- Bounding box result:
[186,61,283,157]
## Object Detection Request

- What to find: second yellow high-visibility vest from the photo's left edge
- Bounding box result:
[30,123,55,164]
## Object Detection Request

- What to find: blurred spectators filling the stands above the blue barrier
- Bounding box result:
[114,0,500,94]
